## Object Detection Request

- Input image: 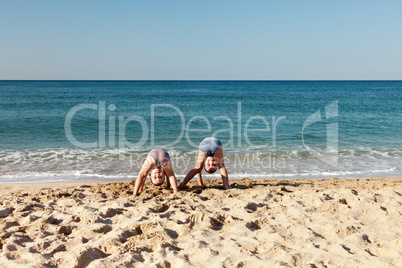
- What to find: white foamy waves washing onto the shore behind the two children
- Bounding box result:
[0,146,402,182]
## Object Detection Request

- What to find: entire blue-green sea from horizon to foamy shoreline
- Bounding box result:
[0,80,402,183]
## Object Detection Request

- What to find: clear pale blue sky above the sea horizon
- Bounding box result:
[0,0,402,80]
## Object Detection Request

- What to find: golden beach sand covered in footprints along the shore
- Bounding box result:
[0,178,402,267]
